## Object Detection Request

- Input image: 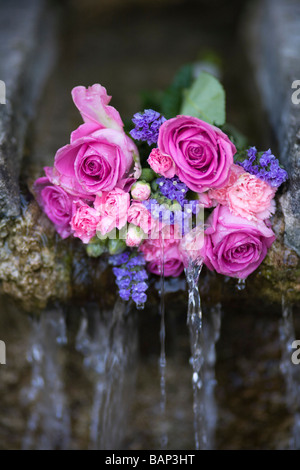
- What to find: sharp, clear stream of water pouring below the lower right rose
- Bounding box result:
[185,260,208,450]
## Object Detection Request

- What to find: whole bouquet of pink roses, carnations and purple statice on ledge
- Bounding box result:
[34,68,287,307]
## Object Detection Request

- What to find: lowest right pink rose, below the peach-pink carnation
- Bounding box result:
[203,205,275,279]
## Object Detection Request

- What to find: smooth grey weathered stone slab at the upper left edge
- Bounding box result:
[0,0,56,217]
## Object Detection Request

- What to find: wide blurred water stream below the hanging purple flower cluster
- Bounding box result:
[76,299,137,450]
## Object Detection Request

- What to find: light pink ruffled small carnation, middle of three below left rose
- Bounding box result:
[94,188,130,235]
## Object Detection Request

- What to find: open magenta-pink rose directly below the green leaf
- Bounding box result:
[158,116,236,193]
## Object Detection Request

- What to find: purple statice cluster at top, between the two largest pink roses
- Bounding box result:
[130,109,166,145]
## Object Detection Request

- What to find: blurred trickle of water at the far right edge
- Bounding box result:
[279,296,300,450]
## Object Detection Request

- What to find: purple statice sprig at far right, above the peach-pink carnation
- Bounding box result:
[237,147,288,188]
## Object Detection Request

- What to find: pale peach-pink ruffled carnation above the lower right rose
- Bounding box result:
[227,173,276,220]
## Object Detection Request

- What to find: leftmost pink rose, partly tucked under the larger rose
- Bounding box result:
[34,176,74,238]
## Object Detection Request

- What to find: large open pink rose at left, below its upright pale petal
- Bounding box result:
[54,129,141,198]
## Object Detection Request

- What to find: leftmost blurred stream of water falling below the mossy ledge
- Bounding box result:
[21,308,70,450]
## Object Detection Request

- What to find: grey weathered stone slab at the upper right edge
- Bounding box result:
[247,0,300,255]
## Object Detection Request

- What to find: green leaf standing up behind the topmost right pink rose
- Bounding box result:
[180,72,225,126]
